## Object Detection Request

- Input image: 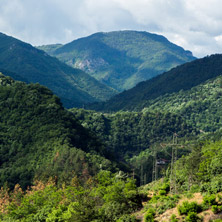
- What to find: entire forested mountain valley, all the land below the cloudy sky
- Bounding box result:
[0,31,222,222]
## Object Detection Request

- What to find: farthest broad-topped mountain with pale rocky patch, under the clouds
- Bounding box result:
[39,31,195,92]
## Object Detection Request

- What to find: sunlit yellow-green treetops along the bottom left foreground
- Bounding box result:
[0,171,141,222]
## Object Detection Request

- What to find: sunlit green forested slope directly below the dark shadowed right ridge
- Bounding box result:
[140,75,222,133]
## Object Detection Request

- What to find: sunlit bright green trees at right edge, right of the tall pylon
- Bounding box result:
[173,139,222,194]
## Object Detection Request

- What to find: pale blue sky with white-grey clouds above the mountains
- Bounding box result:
[0,0,222,58]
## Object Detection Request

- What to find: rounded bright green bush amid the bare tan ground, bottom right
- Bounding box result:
[178,201,202,215]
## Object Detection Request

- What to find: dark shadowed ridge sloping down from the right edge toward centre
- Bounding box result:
[89,54,222,111]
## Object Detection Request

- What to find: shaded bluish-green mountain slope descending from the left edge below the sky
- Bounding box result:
[0,33,115,107]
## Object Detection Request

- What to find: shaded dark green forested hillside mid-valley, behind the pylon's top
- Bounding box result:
[71,109,198,160]
